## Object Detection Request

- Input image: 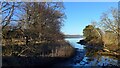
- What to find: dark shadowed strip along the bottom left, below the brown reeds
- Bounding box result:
[2,49,76,68]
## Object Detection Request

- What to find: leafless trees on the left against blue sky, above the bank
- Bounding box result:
[1,2,65,44]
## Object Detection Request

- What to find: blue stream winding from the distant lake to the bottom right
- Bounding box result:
[52,38,118,68]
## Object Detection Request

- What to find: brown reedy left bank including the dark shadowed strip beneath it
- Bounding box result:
[2,41,75,68]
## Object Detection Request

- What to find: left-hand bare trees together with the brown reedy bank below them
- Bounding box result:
[1,2,73,57]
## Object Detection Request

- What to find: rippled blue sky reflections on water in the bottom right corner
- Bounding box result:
[79,56,117,66]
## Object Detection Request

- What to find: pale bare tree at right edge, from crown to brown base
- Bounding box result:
[100,8,120,45]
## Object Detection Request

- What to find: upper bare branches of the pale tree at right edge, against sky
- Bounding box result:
[101,8,120,34]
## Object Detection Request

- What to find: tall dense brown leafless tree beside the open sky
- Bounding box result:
[20,2,65,40]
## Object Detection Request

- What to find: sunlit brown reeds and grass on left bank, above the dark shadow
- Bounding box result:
[2,41,74,57]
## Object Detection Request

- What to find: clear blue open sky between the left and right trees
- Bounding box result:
[61,2,118,35]
